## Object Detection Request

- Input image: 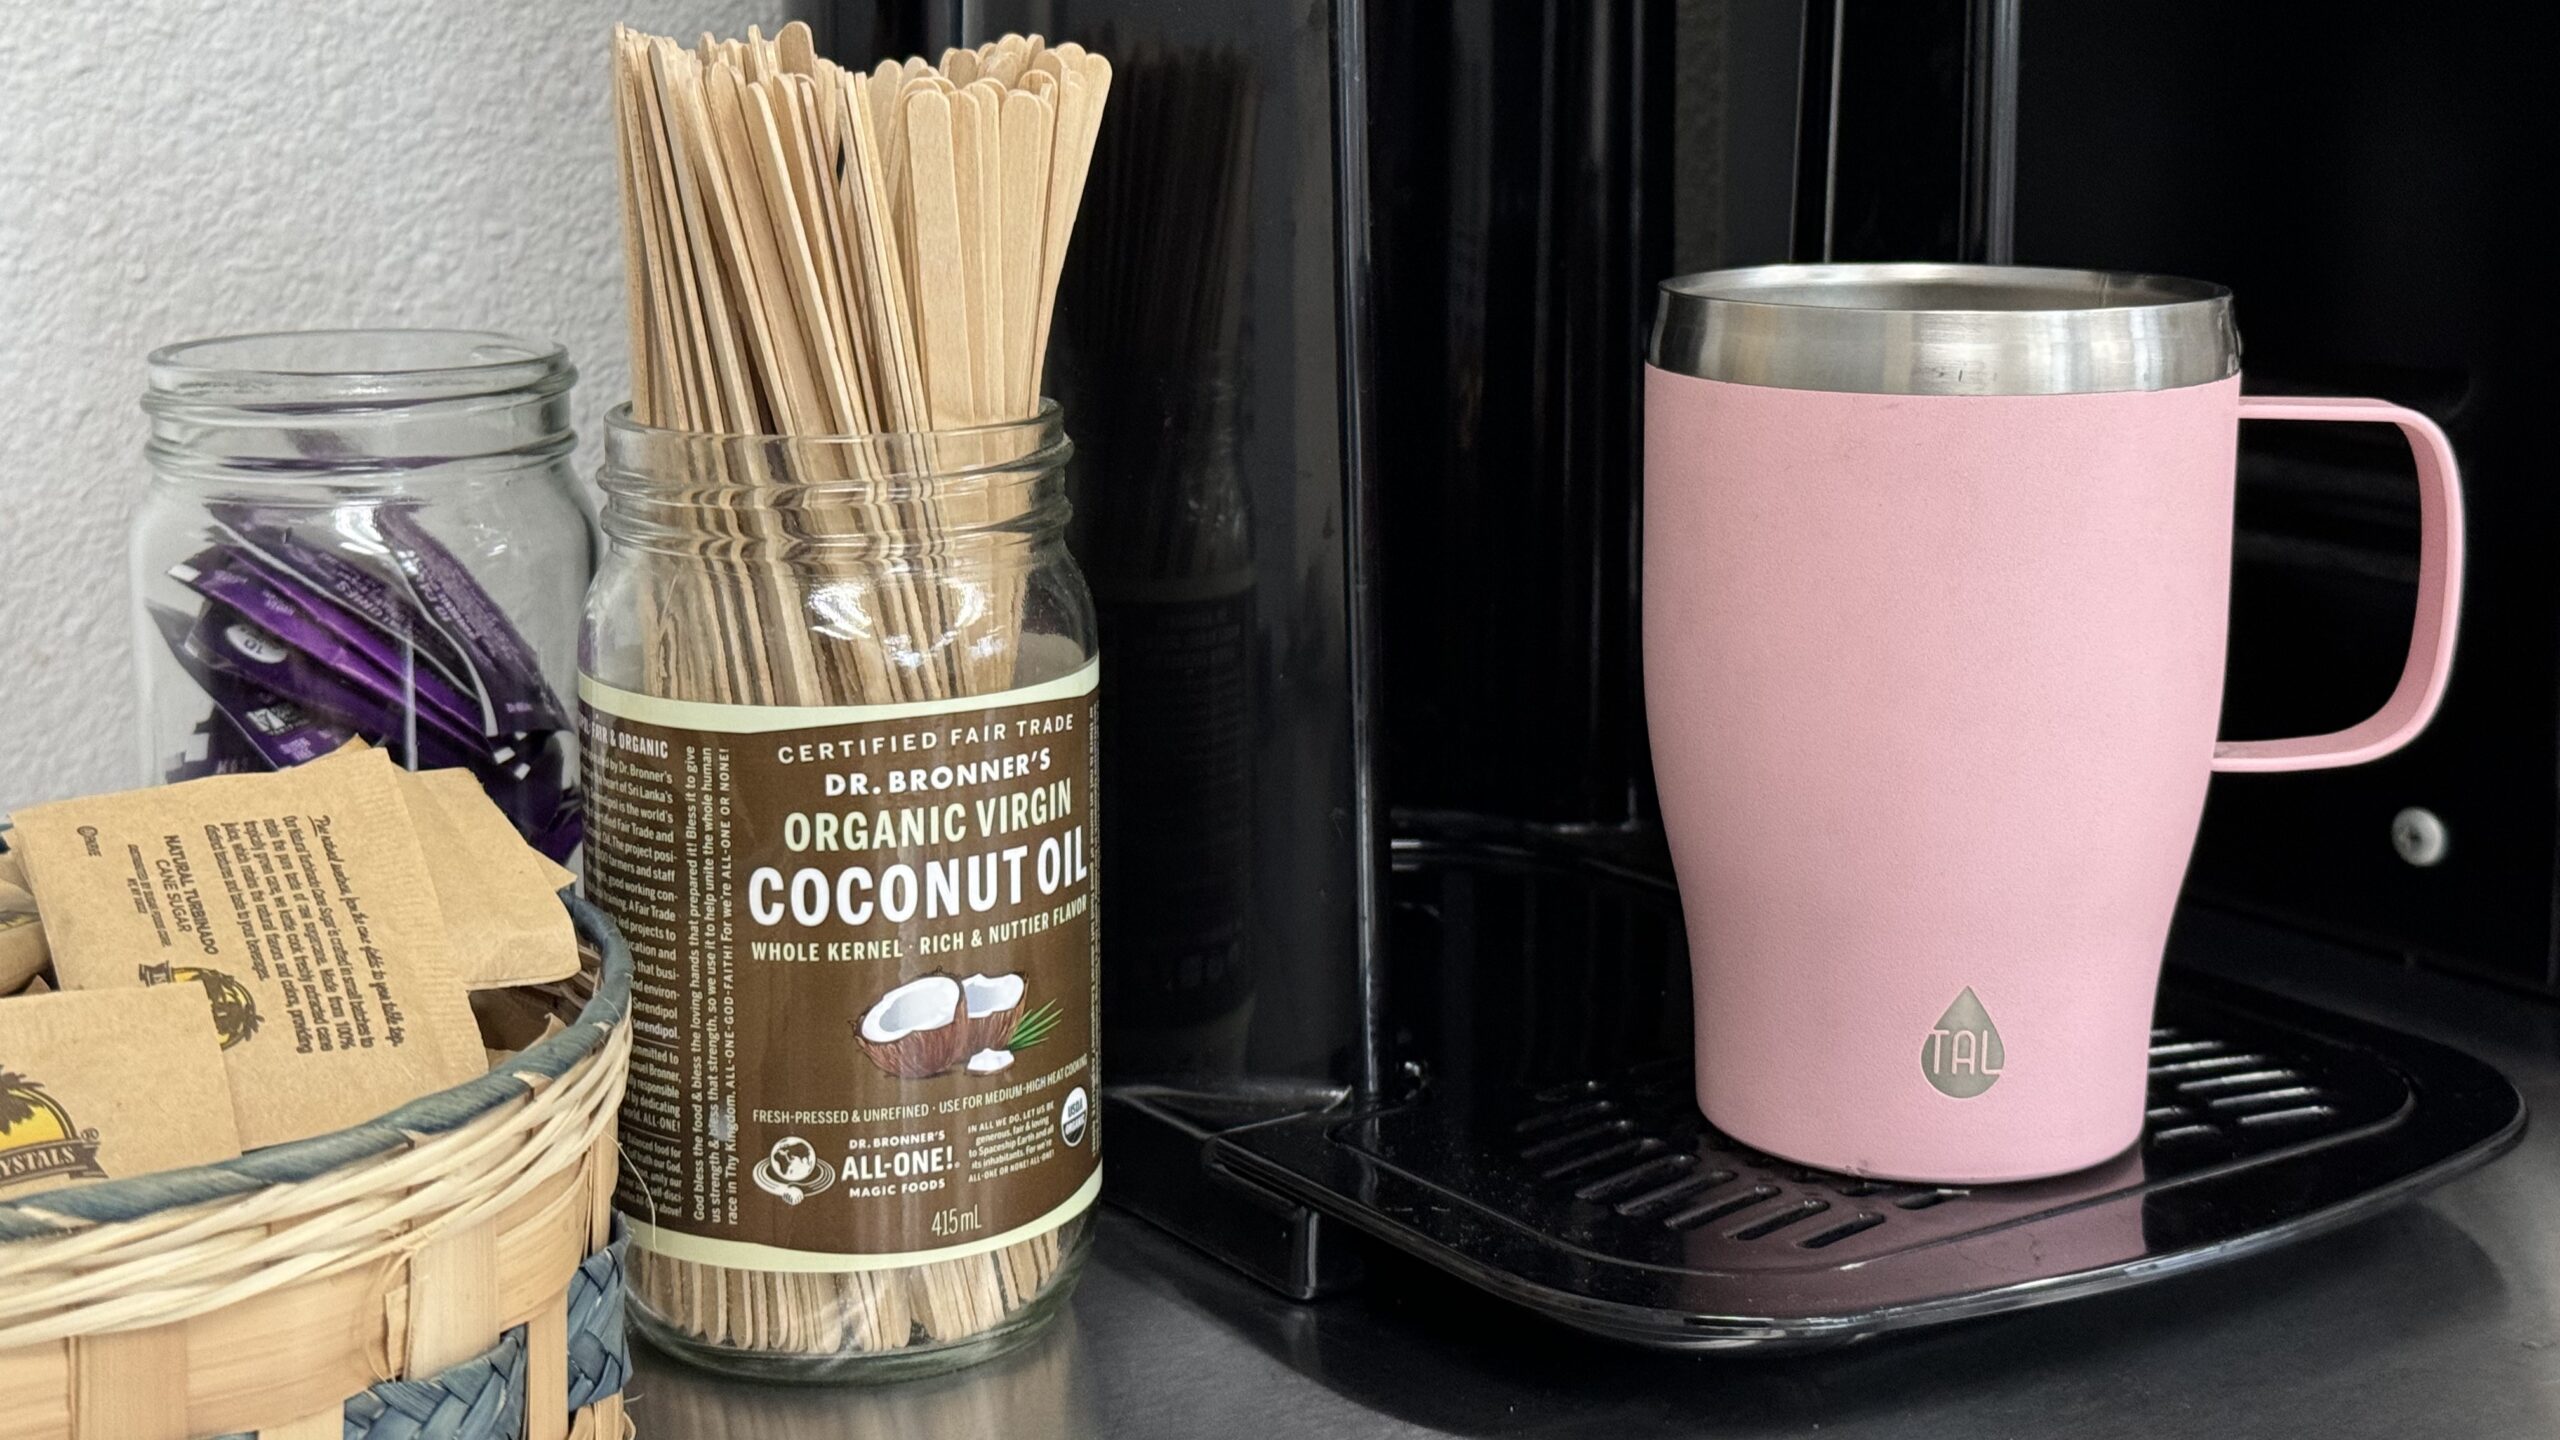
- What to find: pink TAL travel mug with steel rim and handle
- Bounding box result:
[1644,264,2463,1184]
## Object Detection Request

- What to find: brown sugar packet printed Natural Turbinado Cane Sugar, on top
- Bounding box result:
[13,753,486,1148]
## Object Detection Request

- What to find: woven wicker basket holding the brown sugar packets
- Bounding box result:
[0,899,630,1440]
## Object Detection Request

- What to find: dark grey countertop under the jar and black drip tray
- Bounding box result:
[630,912,2560,1440]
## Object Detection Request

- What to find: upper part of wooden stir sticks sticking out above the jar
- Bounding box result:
[614,23,1111,436]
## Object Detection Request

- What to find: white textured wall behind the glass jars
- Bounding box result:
[0,0,794,812]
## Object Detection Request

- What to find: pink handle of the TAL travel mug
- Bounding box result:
[2214,395,2463,771]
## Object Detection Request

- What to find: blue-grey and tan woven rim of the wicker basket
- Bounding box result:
[0,889,632,1245]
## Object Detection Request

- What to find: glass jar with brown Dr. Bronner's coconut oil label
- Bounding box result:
[579,405,1101,1379]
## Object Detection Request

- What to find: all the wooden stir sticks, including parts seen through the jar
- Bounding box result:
[614,23,1111,1355]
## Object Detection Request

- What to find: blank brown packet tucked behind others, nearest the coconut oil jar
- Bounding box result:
[394,756,579,989]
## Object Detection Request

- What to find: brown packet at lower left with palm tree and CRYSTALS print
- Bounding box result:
[0,989,241,1199]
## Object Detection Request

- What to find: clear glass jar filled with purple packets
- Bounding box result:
[131,331,594,858]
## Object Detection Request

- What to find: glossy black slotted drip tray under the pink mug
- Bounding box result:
[1211,845,2524,1350]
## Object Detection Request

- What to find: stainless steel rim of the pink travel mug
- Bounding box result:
[1646,264,2240,395]
